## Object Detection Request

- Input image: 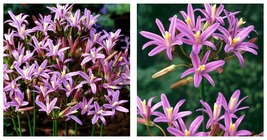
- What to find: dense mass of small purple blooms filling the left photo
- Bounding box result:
[4,4,130,136]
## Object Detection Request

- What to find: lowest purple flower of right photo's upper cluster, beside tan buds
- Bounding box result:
[181,50,224,87]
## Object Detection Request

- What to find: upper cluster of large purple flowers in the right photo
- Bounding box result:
[140,4,258,87]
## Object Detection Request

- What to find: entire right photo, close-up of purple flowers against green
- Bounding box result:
[137,4,264,136]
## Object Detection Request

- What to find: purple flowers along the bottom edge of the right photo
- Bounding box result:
[137,90,252,136]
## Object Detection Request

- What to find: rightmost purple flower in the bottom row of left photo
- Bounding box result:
[103,90,129,114]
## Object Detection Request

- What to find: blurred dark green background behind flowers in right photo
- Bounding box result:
[137,4,263,136]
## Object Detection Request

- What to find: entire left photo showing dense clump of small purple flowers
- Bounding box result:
[3,4,130,136]
